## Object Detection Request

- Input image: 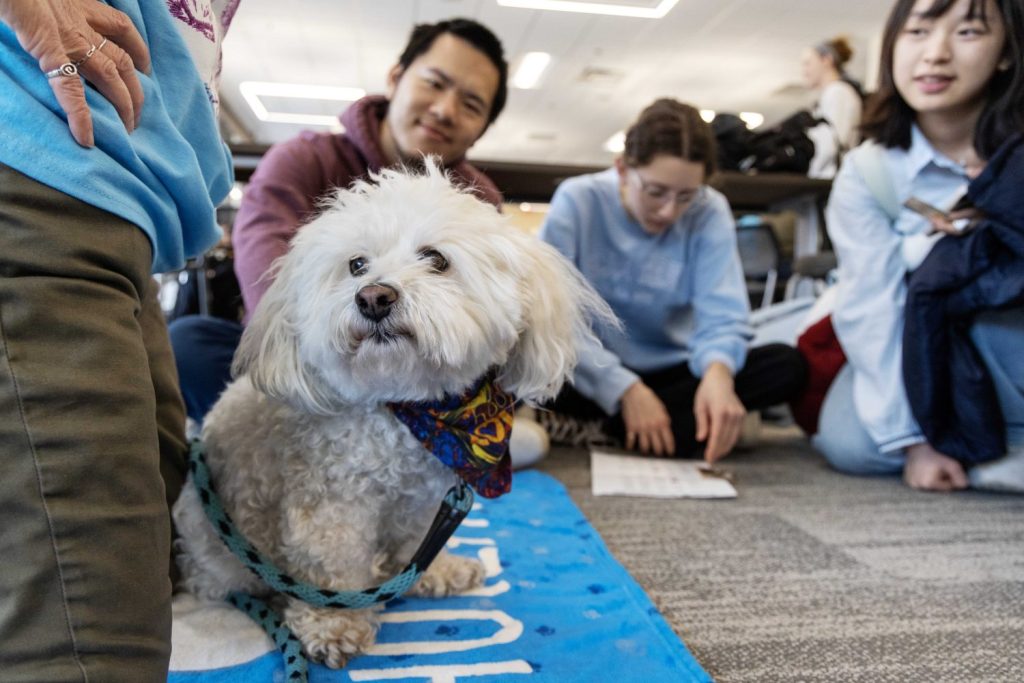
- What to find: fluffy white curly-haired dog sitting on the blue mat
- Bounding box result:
[174,162,612,667]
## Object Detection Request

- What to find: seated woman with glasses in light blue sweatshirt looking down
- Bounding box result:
[541,99,806,462]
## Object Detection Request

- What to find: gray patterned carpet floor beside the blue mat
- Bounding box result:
[539,428,1024,683]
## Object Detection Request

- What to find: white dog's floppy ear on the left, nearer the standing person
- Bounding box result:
[231,256,332,414]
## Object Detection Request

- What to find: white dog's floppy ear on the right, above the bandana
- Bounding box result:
[500,236,620,403]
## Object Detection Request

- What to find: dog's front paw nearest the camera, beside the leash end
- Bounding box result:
[285,602,380,669]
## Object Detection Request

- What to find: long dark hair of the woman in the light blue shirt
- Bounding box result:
[860,0,1024,159]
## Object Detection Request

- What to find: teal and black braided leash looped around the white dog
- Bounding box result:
[188,439,473,683]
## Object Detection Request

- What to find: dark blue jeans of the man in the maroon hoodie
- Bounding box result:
[168,315,243,424]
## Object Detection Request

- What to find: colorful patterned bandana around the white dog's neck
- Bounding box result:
[390,375,515,498]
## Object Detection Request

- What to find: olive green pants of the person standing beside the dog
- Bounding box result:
[0,165,186,683]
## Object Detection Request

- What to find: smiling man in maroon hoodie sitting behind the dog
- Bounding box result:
[170,18,508,422]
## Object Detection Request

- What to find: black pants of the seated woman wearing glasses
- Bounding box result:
[549,344,807,458]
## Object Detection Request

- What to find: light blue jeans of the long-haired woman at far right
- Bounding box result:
[811,308,1024,474]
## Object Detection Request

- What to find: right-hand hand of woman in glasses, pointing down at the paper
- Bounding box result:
[693,362,746,463]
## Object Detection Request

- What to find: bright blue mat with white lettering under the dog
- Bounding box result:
[168,471,712,683]
